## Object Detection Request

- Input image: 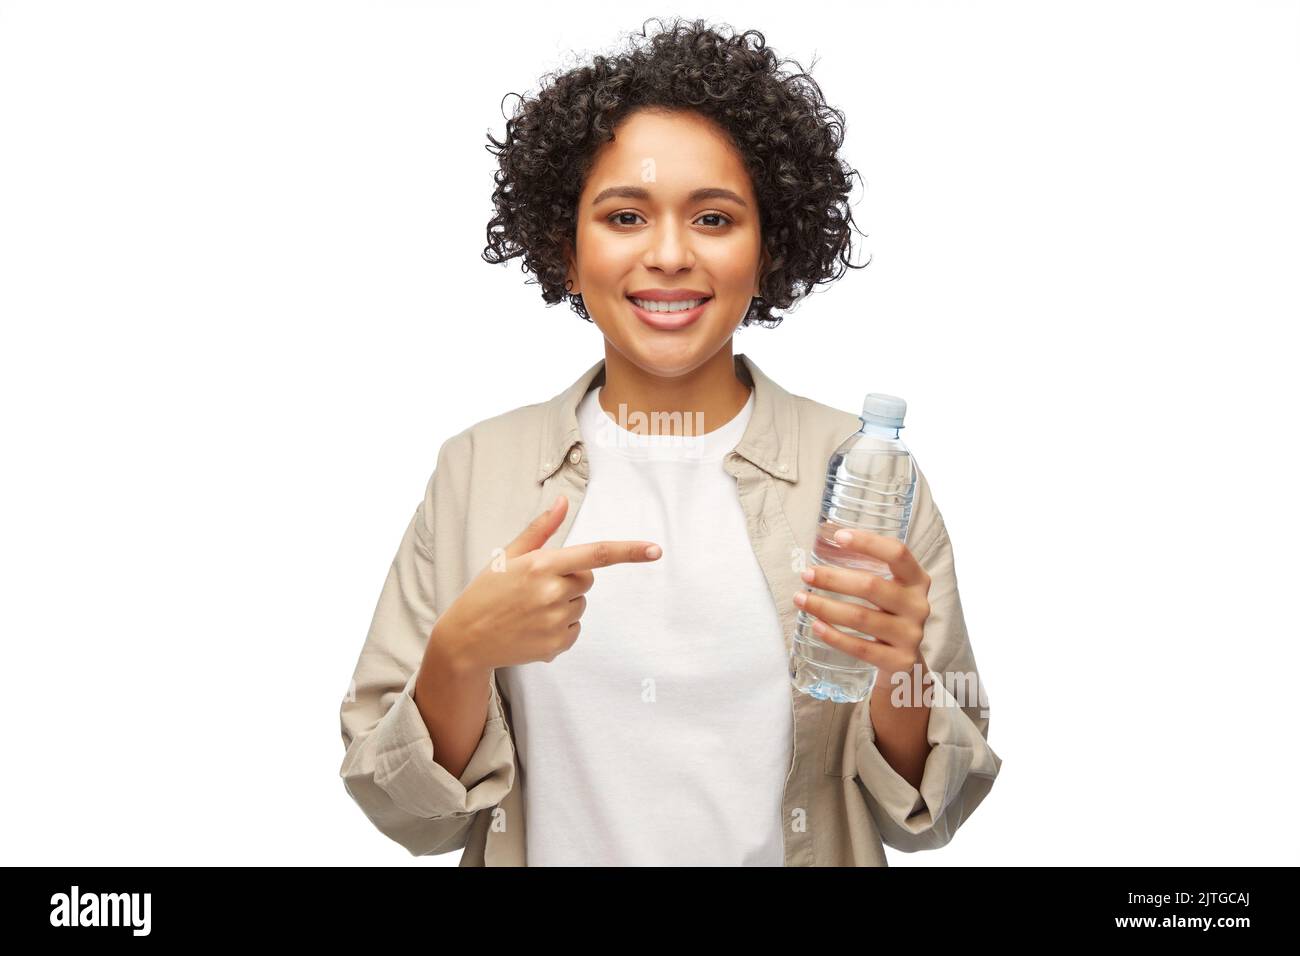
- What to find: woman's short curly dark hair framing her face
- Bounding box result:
[482,18,867,328]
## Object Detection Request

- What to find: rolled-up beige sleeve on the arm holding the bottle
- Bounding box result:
[846,470,1002,852]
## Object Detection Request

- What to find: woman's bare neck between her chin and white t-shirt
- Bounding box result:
[601,339,751,436]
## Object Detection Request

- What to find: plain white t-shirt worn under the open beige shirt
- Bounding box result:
[497,388,793,866]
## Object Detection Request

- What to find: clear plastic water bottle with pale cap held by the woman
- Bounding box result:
[790,392,917,704]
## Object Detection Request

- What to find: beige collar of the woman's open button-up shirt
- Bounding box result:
[537,352,800,483]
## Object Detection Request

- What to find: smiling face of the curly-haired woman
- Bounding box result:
[568,111,766,377]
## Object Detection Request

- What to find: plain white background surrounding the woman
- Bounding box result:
[0,0,1300,866]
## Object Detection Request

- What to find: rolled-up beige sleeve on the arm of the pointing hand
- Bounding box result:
[339,446,516,856]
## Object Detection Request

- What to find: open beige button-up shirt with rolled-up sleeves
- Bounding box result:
[339,354,1002,866]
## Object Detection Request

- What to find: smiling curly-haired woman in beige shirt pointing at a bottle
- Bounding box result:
[341,21,1001,865]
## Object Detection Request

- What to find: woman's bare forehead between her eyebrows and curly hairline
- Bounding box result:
[582,111,753,202]
